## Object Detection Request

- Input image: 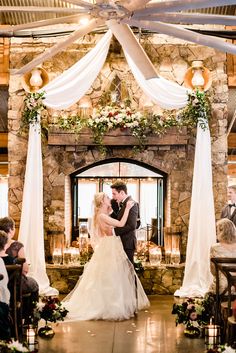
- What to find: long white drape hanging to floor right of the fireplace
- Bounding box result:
[175,121,216,297]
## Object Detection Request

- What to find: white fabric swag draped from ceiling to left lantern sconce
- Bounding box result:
[41,30,112,109]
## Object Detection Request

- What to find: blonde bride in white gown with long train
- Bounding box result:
[63,192,150,320]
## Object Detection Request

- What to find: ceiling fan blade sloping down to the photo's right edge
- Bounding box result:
[122,19,236,54]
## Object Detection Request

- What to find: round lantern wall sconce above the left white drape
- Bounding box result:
[22,67,49,93]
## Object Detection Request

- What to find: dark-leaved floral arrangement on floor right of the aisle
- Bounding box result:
[172,296,213,329]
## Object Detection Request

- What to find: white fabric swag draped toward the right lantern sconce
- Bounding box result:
[124,51,188,109]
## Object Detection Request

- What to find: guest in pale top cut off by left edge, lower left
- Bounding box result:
[0,258,11,340]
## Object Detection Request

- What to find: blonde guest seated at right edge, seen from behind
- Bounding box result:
[209,218,236,293]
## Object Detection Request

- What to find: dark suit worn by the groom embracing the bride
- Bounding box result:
[115,196,139,263]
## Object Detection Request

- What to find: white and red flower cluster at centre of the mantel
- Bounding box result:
[88,105,148,130]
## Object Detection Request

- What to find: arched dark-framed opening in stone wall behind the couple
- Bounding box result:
[71,158,167,245]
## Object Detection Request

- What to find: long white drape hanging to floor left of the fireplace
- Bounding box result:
[18,123,58,295]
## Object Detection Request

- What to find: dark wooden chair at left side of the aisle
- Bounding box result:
[6,260,23,340]
